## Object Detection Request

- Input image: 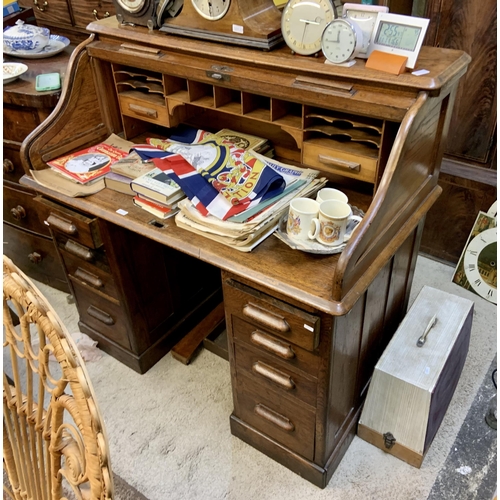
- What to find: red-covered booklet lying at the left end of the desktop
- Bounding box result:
[47,142,128,184]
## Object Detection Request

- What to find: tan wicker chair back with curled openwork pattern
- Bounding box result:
[3,256,113,500]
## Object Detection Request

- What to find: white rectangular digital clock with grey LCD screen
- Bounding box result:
[368,12,429,69]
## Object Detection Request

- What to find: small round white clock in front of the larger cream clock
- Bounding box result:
[321,19,363,64]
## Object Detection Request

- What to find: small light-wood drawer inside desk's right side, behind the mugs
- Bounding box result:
[302,139,377,183]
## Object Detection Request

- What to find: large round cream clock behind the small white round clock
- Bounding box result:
[281,0,335,55]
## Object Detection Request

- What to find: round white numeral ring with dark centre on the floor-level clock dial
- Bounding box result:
[464,228,497,304]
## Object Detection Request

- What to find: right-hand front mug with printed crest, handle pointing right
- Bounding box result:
[308,200,362,246]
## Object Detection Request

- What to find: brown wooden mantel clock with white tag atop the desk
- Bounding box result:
[160,0,283,50]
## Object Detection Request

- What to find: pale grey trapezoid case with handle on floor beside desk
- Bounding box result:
[358,286,474,467]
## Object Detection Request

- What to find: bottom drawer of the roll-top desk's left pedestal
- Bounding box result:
[71,279,130,349]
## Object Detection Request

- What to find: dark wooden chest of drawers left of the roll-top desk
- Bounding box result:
[3,45,74,291]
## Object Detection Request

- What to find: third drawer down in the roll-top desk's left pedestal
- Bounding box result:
[60,249,121,300]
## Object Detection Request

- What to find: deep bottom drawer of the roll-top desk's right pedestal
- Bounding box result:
[234,373,316,460]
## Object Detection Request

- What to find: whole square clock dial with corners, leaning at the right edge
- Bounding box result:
[452,212,497,304]
